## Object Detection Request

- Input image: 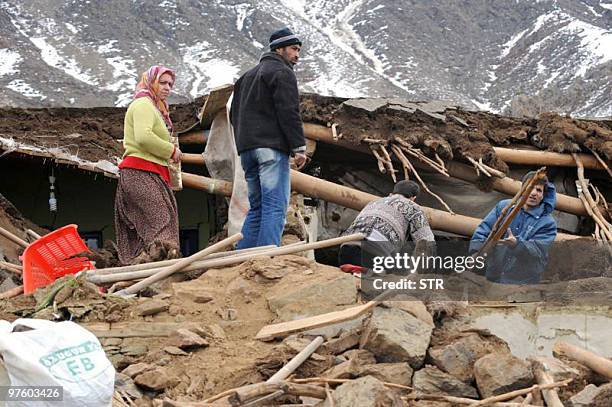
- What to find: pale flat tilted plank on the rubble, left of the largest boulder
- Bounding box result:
[255,301,378,340]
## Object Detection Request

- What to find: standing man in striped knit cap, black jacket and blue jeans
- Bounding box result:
[230,28,306,249]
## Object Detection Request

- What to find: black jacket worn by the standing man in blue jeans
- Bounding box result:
[230,52,305,154]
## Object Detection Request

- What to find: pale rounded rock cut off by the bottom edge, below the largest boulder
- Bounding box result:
[322,376,403,407]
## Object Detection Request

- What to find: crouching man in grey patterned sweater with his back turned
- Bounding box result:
[338,181,435,271]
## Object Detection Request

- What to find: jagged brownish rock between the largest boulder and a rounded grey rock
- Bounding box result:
[428,332,510,383]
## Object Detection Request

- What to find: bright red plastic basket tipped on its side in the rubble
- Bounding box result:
[22,225,94,294]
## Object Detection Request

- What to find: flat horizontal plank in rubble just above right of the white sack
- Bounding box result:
[79,322,200,338]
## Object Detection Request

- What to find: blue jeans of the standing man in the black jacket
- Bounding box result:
[237,148,290,249]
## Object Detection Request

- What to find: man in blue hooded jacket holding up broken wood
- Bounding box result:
[470,171,557,284]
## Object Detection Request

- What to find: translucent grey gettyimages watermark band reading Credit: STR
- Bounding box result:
[360,240,612,305]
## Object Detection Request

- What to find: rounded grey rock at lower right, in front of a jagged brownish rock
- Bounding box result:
[474,353,534,397]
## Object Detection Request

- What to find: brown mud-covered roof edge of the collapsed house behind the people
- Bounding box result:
[0,93,612,179]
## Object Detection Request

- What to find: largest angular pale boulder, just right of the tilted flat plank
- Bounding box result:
[360,307,432,369]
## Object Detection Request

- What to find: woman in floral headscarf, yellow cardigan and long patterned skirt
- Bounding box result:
[115,65,181,264]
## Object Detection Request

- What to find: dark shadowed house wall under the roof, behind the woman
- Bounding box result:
[0,155,215,254]
